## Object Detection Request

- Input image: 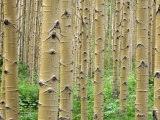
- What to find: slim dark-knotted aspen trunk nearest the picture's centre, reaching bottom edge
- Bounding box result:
[80,0,89,120]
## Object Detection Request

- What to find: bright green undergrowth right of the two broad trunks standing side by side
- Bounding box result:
[73,70,153,120]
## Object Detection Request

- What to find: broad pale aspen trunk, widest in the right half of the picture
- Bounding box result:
[135,0,148,120]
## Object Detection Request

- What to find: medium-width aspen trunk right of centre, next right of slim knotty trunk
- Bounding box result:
[93,0,105,120]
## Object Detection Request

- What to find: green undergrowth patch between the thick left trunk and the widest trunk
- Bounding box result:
[18,62,38,120]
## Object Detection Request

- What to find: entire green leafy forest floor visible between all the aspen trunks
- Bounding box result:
[0,60,153,120]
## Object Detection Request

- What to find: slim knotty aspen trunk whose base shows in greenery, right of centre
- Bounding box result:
[113,0,122,98]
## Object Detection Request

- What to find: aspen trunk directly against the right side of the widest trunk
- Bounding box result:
[59,0,73,120]
